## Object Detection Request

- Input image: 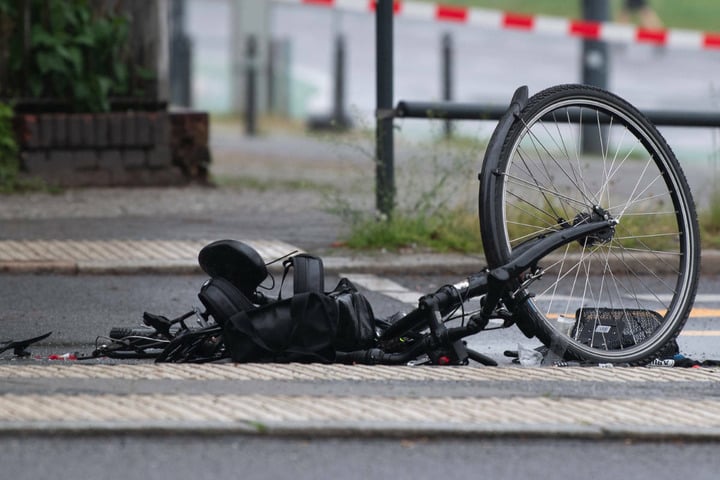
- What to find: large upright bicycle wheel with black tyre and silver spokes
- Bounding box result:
[479,85,700,364]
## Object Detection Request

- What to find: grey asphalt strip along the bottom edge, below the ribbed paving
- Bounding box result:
[5,436,720,480]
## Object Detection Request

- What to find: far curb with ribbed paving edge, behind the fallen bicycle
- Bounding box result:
[0,239,720,276]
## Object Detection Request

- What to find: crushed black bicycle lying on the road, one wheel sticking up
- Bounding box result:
[86,85,700,365]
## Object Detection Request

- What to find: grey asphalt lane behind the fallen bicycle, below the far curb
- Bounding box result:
[0,274,720,364]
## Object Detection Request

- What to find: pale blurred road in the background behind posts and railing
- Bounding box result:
[185,0,720,208]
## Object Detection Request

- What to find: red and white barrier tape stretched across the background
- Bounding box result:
[275,0,720,50]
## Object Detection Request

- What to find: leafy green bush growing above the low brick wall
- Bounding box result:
[5,0,136,112]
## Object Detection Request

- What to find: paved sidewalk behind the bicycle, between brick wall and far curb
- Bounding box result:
[0,126,484,274]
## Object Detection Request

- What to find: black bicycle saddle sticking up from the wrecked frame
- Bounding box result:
[198,240,268,298]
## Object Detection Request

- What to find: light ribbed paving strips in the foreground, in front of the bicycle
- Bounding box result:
[0,364,720,440]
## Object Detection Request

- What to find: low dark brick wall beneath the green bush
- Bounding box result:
[16,112,210,187]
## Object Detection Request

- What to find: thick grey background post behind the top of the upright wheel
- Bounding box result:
[581,0,610,153]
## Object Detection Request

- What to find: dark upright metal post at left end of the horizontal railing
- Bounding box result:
[375,0,395,217]
